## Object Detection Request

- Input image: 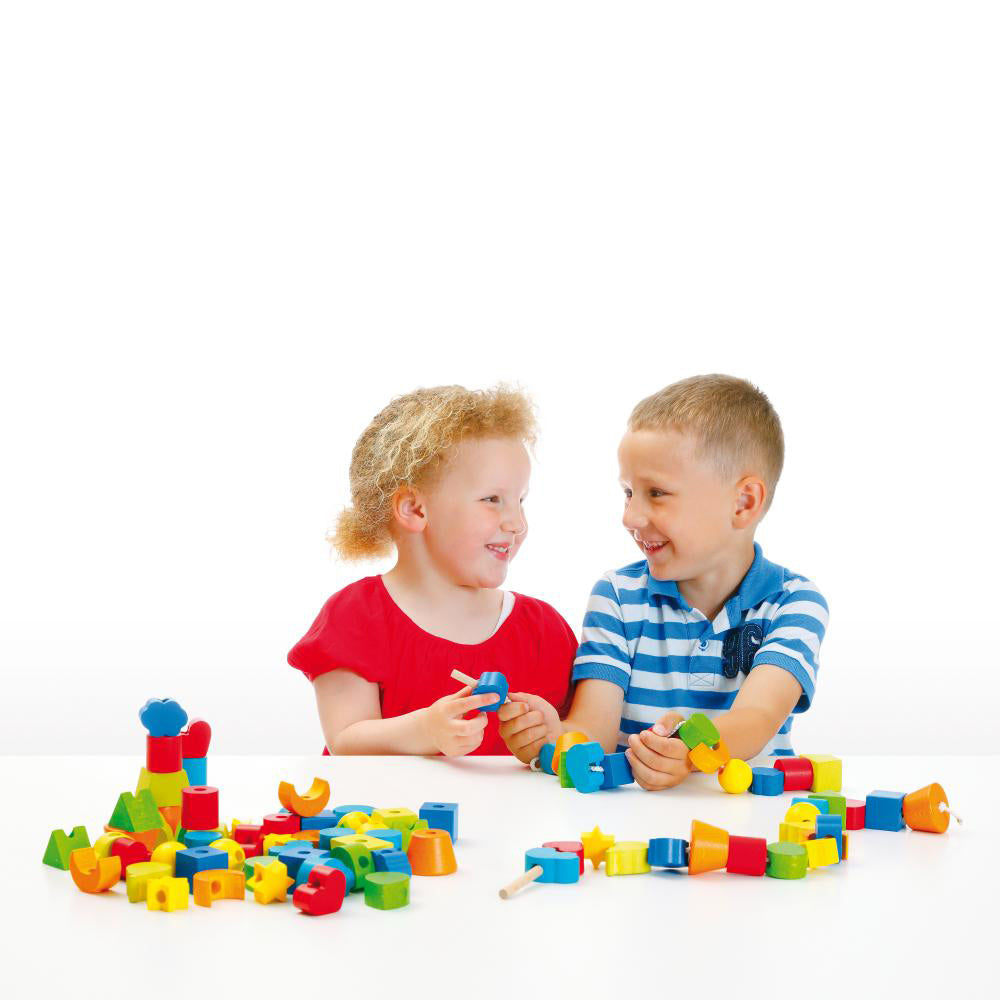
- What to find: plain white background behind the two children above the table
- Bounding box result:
[0,0,1000,754]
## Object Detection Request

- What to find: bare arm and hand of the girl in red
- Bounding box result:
[313,670,496,756]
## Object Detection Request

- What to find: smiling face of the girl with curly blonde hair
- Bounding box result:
[424,438,531,588]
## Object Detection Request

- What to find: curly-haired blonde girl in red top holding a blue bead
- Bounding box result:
[288,386,577,759]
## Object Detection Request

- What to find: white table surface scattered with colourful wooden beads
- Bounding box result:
[0,750,1000,1000]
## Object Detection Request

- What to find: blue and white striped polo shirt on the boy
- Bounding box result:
[573,542,828,756]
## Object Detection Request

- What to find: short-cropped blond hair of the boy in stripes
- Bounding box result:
[628,375,785,514]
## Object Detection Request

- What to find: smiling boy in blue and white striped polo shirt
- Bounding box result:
[498,375,827,790]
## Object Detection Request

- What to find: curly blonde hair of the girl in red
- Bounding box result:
[328,385,536,559]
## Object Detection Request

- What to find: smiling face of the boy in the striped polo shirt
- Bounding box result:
[618,429,752,580]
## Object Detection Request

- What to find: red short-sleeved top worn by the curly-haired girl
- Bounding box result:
[288,576,577,755]
